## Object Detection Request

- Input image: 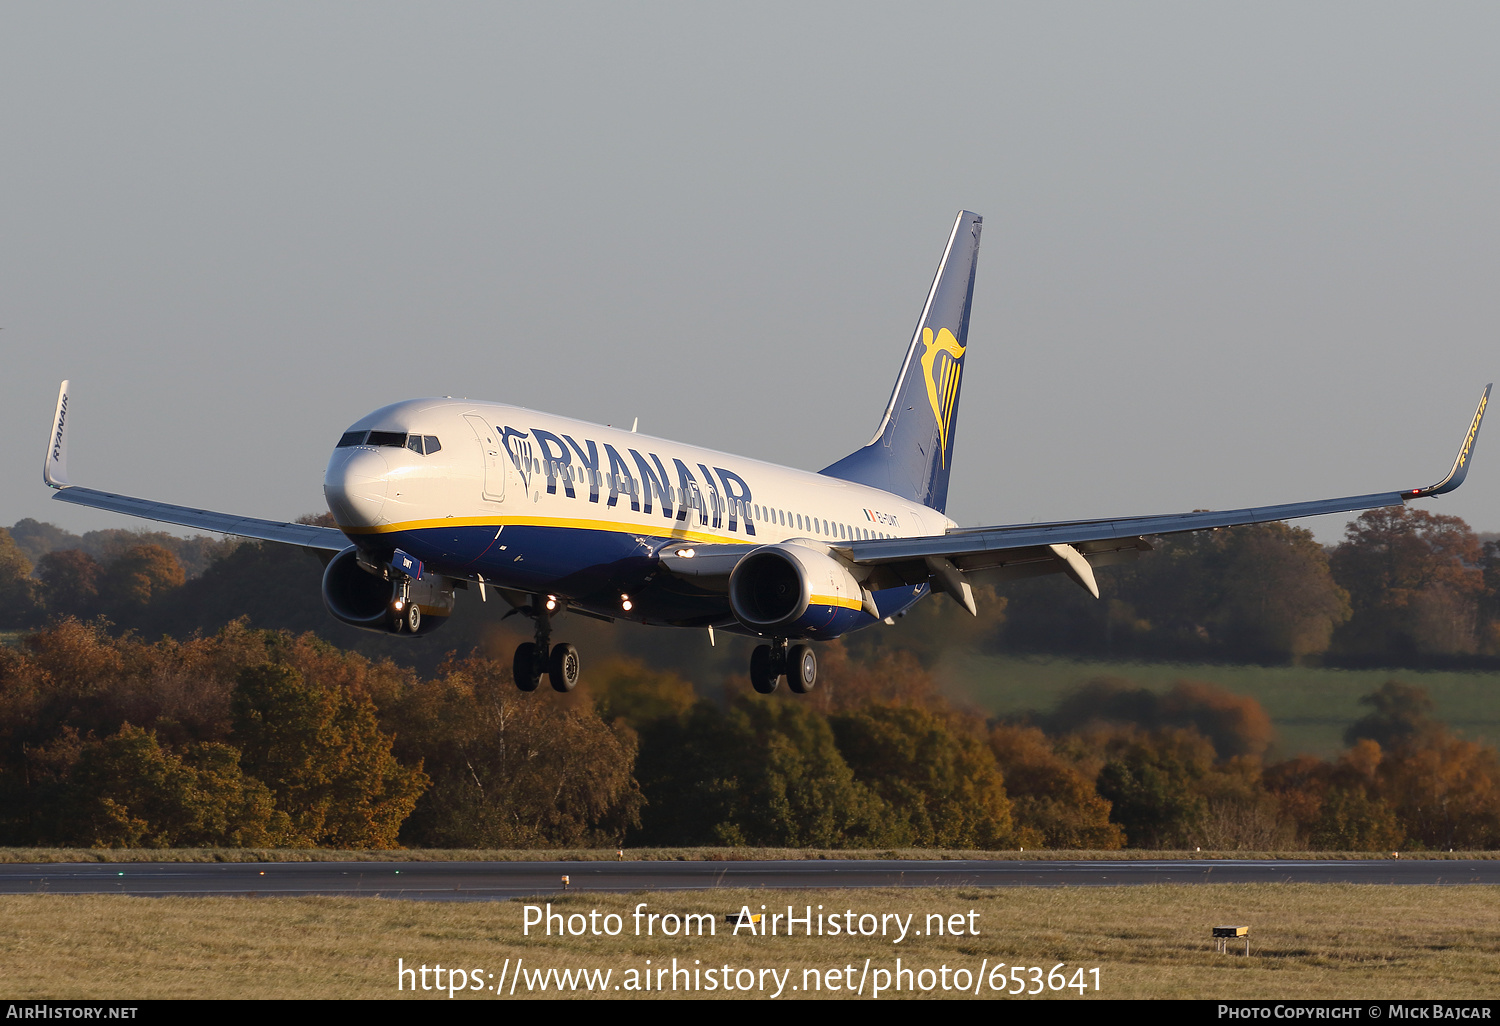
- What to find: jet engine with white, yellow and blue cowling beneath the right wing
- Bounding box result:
[729,545,866,639]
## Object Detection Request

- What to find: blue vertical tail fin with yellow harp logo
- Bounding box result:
[821,210,984,512]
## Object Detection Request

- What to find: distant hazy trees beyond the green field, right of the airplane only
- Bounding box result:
[990,507,1500,668]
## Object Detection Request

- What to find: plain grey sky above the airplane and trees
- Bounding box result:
[0,0,1500,540]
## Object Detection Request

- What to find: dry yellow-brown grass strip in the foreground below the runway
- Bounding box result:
[0,884,1500,1002]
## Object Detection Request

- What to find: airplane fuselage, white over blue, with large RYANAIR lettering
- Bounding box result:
[324,399,953,618]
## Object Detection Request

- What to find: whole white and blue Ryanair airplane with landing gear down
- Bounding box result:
[44,212,1490,695]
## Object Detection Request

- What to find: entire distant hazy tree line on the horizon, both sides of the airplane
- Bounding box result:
[0,507,1500,678]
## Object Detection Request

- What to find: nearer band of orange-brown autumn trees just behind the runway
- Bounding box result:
[0,618,1500,851]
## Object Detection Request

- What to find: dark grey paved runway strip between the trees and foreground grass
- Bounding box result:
[0,860,1500,902]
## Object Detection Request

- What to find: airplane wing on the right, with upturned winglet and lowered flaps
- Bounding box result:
[836,386,1491,612]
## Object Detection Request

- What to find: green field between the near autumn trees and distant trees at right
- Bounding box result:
[936,653,1500,758]
